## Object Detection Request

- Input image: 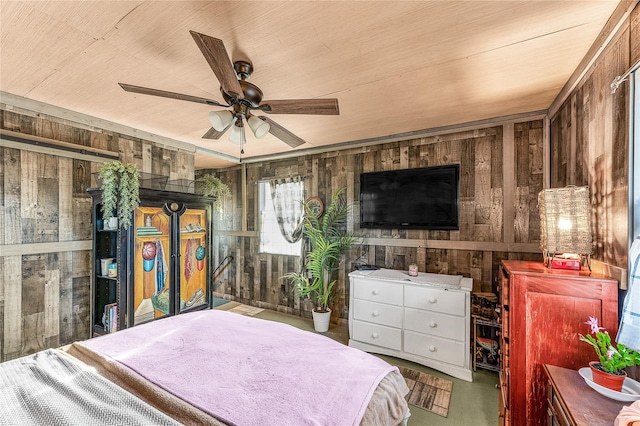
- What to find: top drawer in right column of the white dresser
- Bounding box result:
[404,285,466,316]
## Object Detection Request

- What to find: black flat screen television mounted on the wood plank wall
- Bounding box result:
[360,164,460,230]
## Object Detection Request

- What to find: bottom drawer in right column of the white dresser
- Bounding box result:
[404,330,469,367]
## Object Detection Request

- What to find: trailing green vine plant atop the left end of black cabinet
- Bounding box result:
[99,161,140,229]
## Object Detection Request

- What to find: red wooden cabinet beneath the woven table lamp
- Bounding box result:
[498,260,618,426]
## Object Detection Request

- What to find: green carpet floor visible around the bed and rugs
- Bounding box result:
[235,302,498,426]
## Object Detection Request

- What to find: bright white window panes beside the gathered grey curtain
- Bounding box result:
[258,181,304,256]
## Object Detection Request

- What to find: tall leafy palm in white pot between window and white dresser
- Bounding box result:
[285,189,356,332]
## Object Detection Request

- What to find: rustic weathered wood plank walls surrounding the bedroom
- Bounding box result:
[0,3,640,362]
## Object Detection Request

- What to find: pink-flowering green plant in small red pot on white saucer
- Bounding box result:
[579,317,640,392]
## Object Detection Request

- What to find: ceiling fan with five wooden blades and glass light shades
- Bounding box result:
[118,31,340,148]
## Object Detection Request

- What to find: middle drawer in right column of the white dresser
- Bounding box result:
[404,308,467,341]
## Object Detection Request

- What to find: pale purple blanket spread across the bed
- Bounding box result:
[81,310,397,426]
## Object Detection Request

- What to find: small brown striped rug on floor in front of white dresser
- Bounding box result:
[399,367,453,417]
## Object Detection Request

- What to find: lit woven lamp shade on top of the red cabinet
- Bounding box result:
[538,186,592,258]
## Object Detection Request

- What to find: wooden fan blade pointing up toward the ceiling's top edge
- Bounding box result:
[189,31,244,99]
